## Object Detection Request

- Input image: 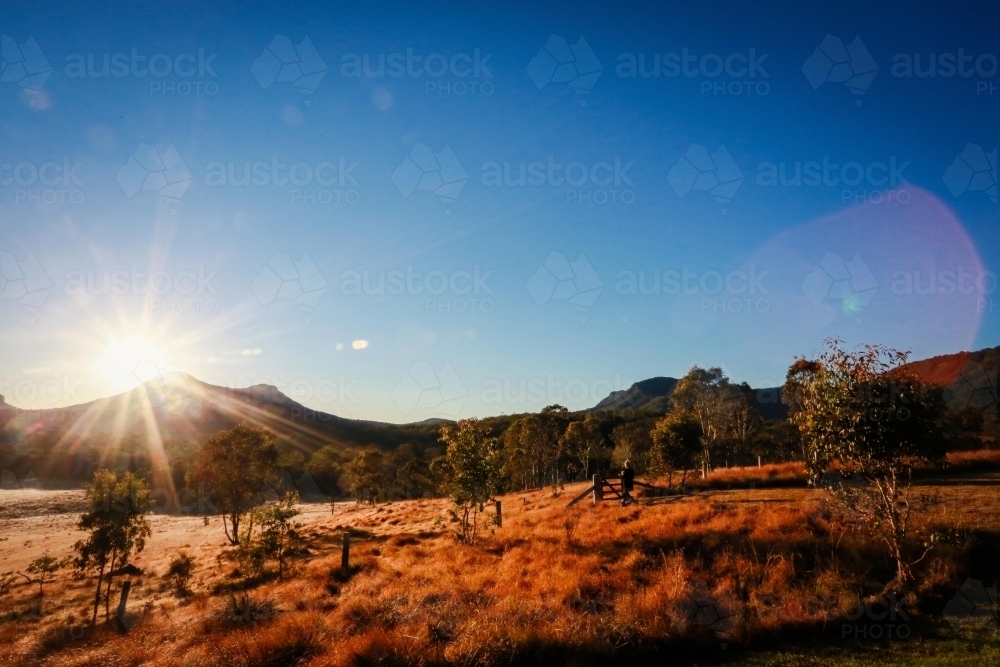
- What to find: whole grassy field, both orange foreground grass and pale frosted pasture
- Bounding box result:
[0,456,1000,666]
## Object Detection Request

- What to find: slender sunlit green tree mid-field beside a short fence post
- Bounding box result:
[441,419,502,544]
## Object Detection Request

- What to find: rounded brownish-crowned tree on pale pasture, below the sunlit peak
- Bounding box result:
[188,424,279,545]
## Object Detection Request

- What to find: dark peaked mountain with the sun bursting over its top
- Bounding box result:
[0,373,439,479]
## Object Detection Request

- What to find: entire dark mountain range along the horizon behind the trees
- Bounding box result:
[0,347,1000,479]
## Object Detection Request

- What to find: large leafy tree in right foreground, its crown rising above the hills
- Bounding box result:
[785,339,945,586]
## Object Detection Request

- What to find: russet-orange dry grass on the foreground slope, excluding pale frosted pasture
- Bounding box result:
[0,456,1000,667]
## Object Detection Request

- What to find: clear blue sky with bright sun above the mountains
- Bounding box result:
[0,1,1000,422]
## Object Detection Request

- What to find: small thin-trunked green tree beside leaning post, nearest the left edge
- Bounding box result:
[73,470,151,623]
